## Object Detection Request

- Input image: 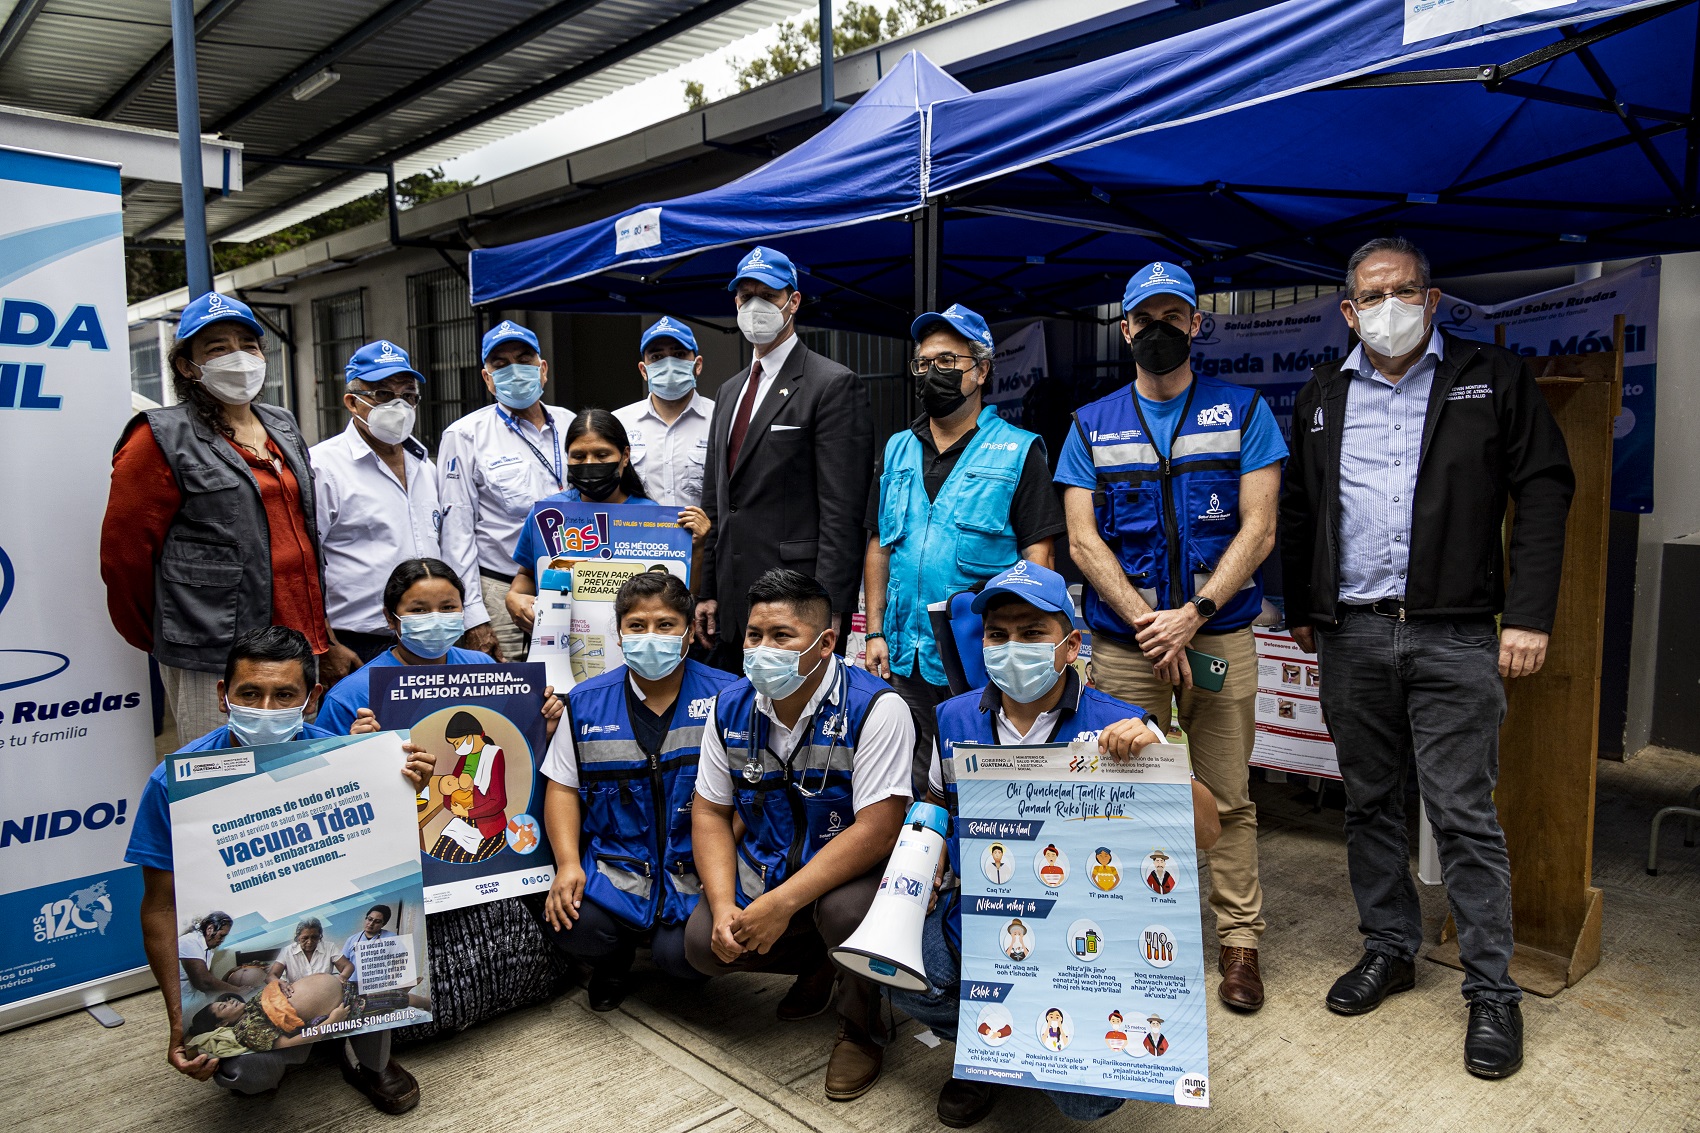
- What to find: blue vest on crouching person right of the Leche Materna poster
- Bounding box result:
[566,660,733,929]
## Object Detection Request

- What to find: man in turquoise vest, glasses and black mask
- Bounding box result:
[864,303,1068,784]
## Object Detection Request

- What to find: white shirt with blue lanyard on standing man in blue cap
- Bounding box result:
[437,405,573,594]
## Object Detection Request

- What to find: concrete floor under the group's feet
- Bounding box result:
[13,752,1700,1133]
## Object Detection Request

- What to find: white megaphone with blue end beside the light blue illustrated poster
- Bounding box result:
[831,792,950,992]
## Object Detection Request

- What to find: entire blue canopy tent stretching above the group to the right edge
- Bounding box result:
[473,0,1700,333]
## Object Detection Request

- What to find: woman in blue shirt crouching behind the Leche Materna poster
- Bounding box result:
[334,558,570,1039]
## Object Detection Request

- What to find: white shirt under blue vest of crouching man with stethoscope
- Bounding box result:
[697,653,915,813]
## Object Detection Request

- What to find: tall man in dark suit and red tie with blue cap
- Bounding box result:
[695,247,874,656]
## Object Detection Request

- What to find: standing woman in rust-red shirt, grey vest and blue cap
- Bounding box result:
[100,293,357,743]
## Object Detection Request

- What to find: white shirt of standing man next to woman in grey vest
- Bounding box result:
[308,420,490,633]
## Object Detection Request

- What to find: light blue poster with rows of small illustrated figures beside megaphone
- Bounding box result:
[955,740,1210,1107]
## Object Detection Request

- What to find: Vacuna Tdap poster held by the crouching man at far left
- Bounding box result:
[167,733,432,1058]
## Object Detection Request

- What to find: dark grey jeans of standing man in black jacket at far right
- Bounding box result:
[1316,611,1523,1002]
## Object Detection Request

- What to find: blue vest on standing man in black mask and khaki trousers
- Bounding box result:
[1074,376,1263,640]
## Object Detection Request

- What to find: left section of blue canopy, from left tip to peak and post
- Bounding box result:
[471,51,967,320]
